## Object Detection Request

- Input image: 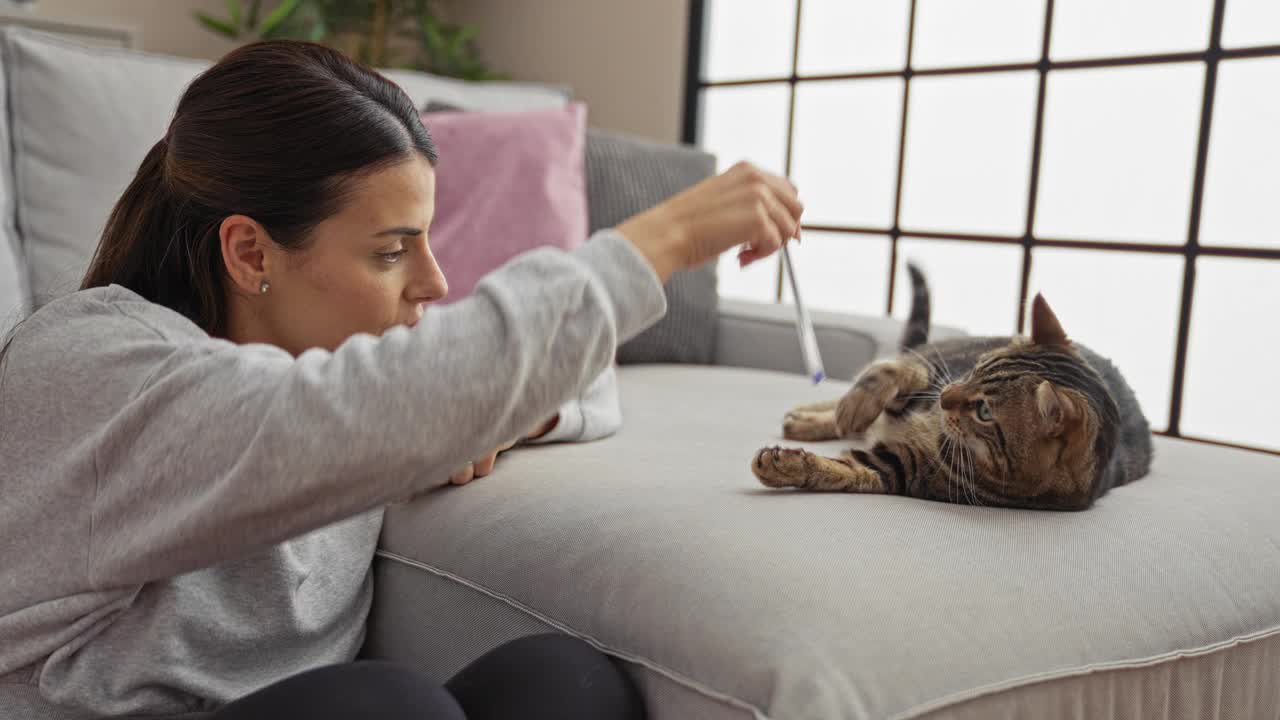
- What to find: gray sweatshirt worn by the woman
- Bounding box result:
[0,232,666,717]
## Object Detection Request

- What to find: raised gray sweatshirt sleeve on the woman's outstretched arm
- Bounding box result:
[87,231,666,588]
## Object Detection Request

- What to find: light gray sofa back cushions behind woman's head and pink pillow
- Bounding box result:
[0,27,566,320]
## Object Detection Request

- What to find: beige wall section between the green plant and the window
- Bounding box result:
[447,0,689,142]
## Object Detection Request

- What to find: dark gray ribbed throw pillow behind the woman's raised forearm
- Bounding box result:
[424,101,719,365]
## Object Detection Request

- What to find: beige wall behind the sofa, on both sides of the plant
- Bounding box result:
[18,0,689,141]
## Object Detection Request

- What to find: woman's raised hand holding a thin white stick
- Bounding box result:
[618,163,804,282]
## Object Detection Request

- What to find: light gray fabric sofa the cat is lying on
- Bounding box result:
[0,25,1280,720]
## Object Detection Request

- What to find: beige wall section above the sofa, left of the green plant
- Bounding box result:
[8,0,234,59]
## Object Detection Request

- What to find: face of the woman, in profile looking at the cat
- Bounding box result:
[241,154,449,355]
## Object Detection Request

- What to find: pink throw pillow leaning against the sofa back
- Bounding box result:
[422,102,588,302]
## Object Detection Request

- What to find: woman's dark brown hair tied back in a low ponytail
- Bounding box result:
[81,41,435,334]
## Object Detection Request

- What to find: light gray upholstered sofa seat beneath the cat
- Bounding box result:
[369,365,1280,720]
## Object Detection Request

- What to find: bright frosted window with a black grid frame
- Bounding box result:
[685,0,1280,452]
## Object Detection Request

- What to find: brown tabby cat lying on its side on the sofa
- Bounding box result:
[751,266,1152,510]
